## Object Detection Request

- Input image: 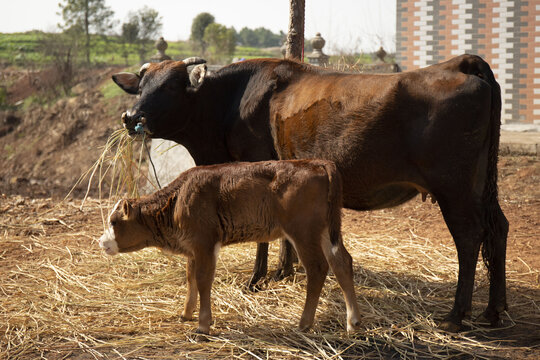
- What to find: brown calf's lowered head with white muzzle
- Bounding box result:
[99,200,152,255]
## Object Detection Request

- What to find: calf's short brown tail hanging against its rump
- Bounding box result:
[323,161,343,246]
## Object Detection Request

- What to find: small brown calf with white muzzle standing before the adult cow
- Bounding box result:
[99,160,360,334]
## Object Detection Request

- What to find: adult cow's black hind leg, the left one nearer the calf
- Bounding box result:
[436,191,486,332]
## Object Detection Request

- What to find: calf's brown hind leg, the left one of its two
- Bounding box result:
[291,235,328,331]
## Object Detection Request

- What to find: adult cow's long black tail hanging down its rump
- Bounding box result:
[462,56,508,274]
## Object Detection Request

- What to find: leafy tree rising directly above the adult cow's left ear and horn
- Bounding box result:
[122,6,163,63]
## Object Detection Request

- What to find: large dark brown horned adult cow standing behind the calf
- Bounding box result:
[113,54,508,331]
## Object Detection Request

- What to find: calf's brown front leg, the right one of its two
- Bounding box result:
[195,244,219,334]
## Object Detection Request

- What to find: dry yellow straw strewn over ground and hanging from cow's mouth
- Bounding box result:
[0,132,540,359]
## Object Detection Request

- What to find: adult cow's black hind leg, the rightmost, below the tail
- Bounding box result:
[482,202,508,326]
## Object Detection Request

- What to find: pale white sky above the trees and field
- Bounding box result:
[0,0,396,54]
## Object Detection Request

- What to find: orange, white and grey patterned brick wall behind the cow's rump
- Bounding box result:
[396,0,540,123]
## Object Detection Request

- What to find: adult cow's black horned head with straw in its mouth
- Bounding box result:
[112,57,206,140]
